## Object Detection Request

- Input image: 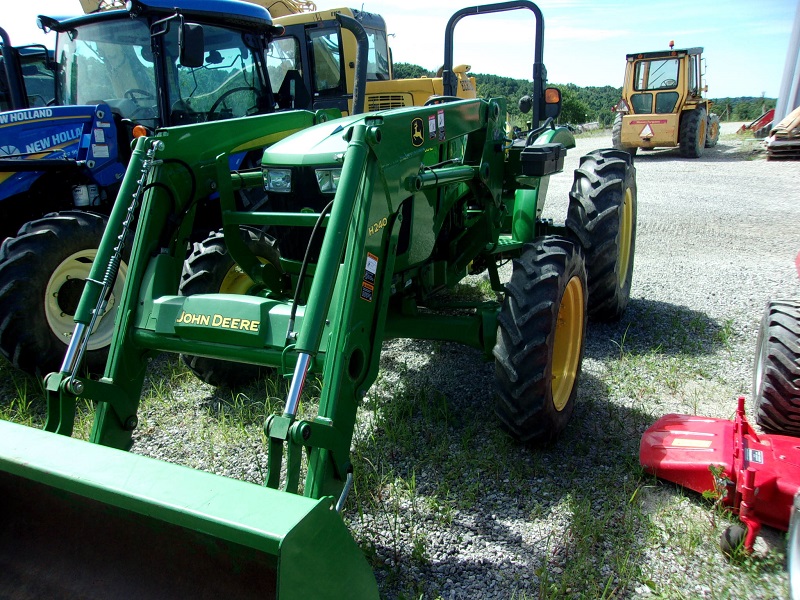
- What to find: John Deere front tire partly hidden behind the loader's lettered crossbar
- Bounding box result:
[179,227,280,388]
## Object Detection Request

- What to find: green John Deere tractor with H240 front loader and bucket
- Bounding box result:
[0,0,636,599]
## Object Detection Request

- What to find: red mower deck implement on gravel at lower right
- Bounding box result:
[639,398,800,550]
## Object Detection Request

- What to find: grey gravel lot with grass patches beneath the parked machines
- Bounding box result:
[125,124,800,598]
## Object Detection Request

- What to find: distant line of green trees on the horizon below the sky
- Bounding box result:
[393,63,776,127]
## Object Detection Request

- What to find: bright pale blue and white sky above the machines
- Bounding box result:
[0,0,800,98]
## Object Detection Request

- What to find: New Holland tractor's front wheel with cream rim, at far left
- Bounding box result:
[0,210,128,376]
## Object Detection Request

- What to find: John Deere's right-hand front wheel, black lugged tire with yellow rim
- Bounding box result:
[494,236,587,444]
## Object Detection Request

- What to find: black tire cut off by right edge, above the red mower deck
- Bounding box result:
[753,300,800,436]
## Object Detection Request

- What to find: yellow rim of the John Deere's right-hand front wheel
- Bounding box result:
[552,277,585,412]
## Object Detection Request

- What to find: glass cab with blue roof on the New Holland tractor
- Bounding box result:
[39,0,282,131]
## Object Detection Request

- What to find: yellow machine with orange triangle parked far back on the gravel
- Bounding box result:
[611,41,719,158]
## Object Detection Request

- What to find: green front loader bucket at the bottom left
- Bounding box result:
[0,421,378,600]
